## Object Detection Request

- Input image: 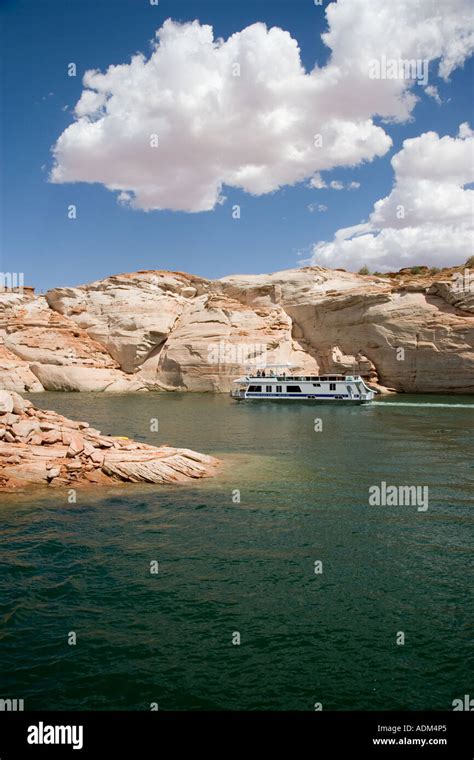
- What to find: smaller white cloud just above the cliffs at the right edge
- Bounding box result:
[312,124,474,272]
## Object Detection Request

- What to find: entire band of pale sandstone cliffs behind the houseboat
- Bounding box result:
[0,267,474,393]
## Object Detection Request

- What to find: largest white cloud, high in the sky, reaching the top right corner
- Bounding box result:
[50,0,474,212]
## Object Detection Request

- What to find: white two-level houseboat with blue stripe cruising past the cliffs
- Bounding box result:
[230,365,376,404]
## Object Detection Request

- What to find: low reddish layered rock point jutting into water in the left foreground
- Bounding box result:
[0,391,219,491]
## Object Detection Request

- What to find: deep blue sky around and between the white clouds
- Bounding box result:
[0,0,473,290]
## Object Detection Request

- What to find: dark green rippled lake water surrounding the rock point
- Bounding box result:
[0,393,474,710]
